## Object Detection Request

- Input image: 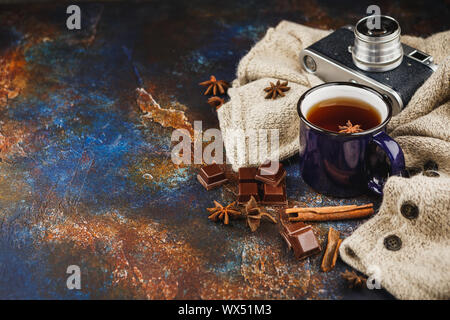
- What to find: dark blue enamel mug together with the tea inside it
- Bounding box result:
[297,82,405,197]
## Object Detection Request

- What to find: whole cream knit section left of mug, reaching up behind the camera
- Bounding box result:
[217,21,330,171]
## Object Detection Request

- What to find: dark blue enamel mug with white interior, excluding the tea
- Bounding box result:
[297,82,405,197]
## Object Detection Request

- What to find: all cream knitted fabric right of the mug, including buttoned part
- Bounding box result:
[340,54,450,299]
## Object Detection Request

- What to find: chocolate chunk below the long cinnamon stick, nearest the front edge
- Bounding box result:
[280,222,321,259]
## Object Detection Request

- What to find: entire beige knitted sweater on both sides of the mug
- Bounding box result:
[218,21,450,299]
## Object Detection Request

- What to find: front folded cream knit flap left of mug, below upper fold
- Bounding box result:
[218,78,307,171]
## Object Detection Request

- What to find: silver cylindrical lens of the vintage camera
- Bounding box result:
[352,15,403,72]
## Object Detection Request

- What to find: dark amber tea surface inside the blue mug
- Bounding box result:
[306,97,381,132]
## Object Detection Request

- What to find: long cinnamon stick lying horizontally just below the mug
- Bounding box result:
[285,203,374,222]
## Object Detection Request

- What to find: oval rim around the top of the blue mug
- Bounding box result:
[297,81,392,137]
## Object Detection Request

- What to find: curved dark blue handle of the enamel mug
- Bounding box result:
[367,131,405,195]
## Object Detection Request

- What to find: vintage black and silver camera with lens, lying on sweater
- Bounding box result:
[300,16,437,115]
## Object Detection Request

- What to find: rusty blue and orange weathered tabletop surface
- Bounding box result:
[0,0,449,299]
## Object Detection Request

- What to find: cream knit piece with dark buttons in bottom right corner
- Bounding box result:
[339,173,450,299]
